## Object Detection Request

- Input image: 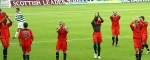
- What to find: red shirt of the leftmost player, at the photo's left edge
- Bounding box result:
[0,23,12,38]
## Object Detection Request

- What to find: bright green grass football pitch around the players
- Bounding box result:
[0,3,150,60]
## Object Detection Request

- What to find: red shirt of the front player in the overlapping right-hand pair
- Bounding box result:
[130,22,142,38]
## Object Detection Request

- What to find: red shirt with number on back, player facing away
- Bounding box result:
[18,29,34,46]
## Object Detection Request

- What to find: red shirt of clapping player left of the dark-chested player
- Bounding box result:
[57,28,68,41]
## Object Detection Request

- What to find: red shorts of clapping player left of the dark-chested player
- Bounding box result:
[56,41,67,51]
